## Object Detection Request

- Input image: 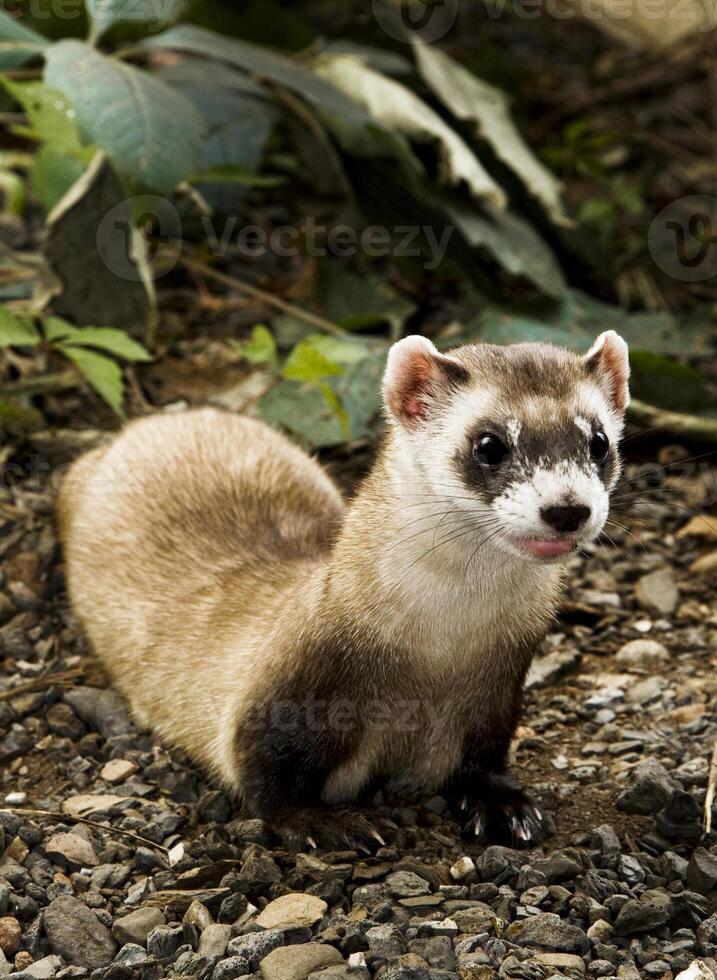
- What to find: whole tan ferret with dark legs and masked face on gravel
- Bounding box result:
[58,331,629,847]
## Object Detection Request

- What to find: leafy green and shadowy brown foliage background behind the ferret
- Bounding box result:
[0,0,717,452]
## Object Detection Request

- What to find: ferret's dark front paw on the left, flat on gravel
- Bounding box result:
[272,806,386,854]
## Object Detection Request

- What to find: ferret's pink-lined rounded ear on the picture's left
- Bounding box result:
[383,335,470,429]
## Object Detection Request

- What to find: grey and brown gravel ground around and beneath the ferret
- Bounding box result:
[0,456,717,980]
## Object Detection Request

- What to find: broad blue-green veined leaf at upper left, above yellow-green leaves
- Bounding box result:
[45,40,203,193]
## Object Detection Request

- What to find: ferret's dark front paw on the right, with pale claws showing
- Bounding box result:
[459,775,546,847]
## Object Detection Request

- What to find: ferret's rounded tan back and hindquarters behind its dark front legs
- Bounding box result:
[58,409,344,789]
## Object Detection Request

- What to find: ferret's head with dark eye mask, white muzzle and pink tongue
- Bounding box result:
[383,330,629,562]
